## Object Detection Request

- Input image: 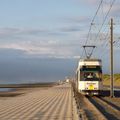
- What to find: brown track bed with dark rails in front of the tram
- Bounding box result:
[73,81,120,120]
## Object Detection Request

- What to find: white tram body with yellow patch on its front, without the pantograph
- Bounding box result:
[75,59,102,95]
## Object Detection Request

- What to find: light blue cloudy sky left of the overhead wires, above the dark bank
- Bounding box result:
[0,0,96,57]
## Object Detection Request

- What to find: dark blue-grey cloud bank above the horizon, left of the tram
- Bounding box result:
[0,57,78,84]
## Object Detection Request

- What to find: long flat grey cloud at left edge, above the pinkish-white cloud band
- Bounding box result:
[0,27,70,40]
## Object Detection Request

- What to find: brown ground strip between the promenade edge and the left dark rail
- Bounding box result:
[75,88,107,120]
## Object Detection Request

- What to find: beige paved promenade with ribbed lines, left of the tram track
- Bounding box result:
[0,84,72,120]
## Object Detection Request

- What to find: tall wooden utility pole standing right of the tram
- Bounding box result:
[110,18,114,97]
